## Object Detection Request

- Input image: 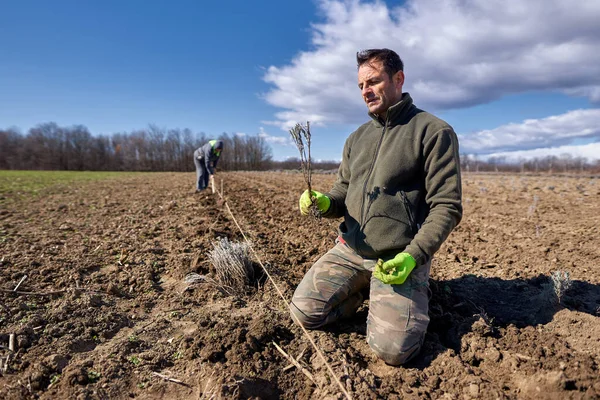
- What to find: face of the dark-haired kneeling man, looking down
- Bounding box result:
[358,61,404,118]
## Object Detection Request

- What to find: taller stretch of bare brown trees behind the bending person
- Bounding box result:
[0,123,277,171]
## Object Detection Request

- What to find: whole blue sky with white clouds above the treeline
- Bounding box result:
[0,0,600,160]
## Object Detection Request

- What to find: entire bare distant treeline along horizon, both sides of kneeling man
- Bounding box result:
[0,122,600,174]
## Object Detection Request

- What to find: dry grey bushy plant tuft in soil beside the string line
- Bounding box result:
[208,238,254,295]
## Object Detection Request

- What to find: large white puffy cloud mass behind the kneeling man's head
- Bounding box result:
[264,0,600,129]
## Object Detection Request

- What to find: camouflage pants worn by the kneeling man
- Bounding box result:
[291,239,431,365]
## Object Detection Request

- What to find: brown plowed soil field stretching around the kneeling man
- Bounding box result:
[0,173,600,399]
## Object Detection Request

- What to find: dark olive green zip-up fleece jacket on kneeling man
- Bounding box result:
[324,93,462,266]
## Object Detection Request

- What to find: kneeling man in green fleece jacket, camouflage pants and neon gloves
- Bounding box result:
[291,49,462,365]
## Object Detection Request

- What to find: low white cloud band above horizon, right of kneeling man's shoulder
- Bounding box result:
[459,108,600,154]
